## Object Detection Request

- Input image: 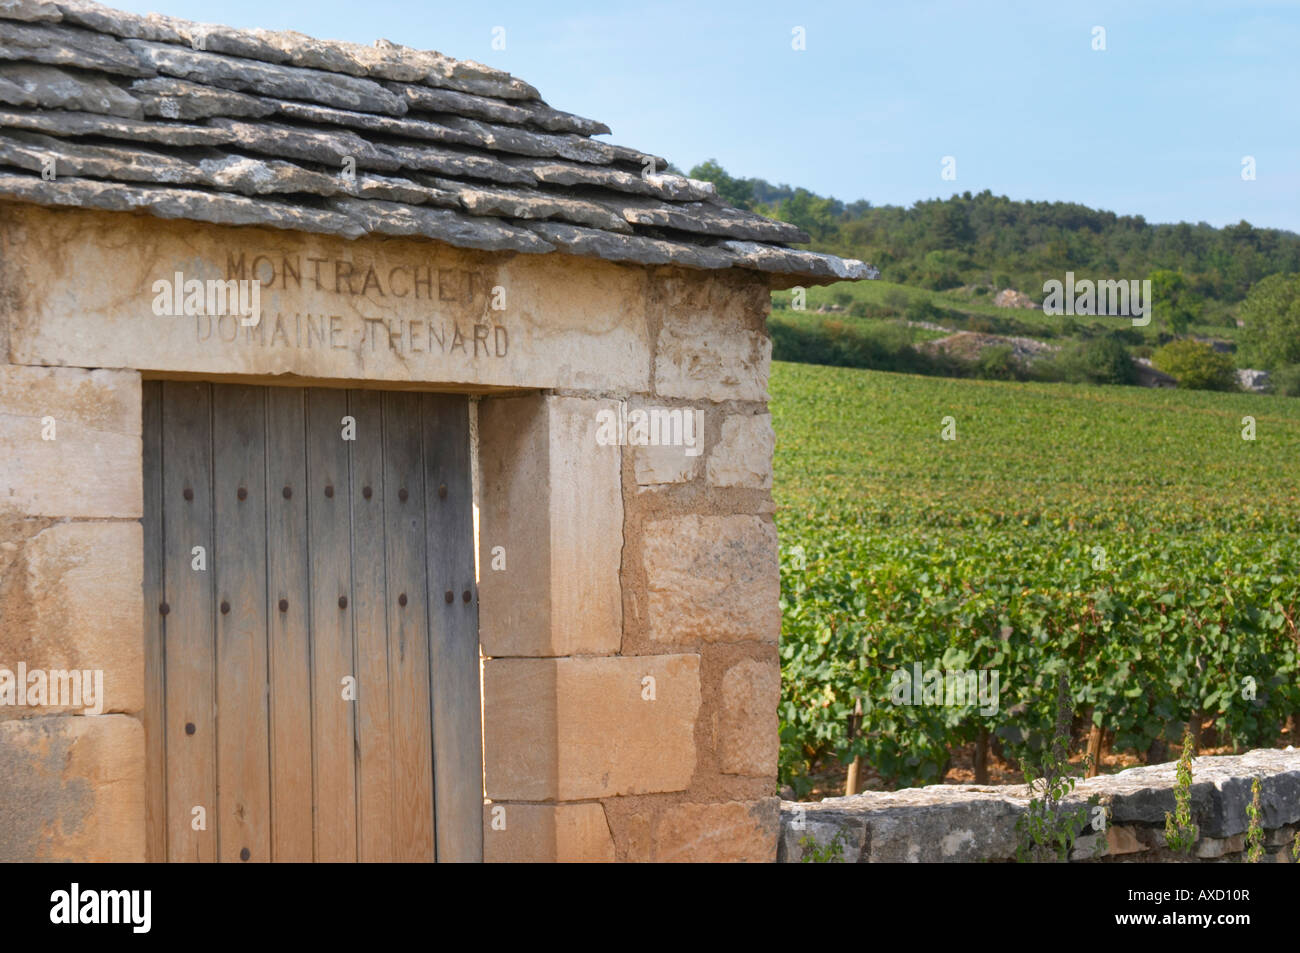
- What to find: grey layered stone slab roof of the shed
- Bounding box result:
[0,0,878,286]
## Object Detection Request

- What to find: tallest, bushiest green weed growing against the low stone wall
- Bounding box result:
[1015,672,1099,863]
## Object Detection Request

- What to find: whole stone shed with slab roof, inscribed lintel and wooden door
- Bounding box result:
[0,0,874,862]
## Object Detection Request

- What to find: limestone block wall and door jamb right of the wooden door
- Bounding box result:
[478,269,780,861]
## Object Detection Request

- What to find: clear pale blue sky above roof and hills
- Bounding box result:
[111,0,1300,231]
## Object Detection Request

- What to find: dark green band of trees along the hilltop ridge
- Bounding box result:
[692,161,1300,310]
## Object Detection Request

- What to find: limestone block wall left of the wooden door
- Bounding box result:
[0,361,144,861]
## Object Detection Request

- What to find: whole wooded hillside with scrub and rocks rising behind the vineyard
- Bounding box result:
[692,161,1300,397]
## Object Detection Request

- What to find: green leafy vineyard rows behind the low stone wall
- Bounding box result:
[771,363,1300,796]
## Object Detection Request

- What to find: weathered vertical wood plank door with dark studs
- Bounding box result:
[142,381,482,863]
